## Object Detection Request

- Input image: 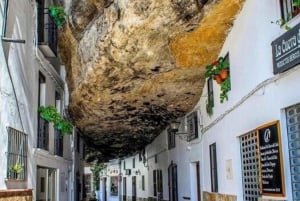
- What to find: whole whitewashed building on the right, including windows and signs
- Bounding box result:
[100,0,300,201]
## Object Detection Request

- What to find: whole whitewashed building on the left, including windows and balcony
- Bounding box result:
[0,0,83,201]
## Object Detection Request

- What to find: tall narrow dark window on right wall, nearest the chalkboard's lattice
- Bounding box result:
[209,143,218,192]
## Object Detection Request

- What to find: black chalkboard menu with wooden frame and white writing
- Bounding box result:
[258,121,285,196]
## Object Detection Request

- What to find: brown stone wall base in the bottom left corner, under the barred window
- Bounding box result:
[0,189,32,201]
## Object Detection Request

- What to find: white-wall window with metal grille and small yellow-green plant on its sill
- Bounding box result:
[6,127,27,180]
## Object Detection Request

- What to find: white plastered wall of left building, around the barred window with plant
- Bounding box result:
[0,0,72,200]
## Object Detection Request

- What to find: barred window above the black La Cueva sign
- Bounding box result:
[280,0,300,22]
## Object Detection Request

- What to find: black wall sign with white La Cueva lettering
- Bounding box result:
[272,24,300,74]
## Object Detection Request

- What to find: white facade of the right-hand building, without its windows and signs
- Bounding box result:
[102,0,300,201]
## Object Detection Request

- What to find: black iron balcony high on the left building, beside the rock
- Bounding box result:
[38,8,57,57]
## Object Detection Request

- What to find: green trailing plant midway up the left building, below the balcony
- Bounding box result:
[38,105,73,135]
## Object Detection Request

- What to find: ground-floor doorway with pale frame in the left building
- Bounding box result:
[36,167,58,201]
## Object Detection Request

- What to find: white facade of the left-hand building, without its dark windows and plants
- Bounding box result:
[0,0,79,201]
